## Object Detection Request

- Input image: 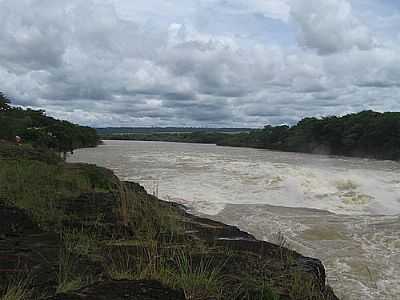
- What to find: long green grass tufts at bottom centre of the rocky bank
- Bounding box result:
[106,244,223,300]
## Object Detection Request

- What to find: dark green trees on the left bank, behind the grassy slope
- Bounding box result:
[0,92,99,152]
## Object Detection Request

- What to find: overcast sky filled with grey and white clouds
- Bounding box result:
[0,0,400,127]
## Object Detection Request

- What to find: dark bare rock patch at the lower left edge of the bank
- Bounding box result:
[0,206,60,293]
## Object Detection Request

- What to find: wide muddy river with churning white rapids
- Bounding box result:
[68,141,400,300]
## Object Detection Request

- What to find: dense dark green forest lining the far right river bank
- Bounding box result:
[103,111,400,160]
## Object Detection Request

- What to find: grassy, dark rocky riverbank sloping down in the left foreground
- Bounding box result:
[0,141,336,300]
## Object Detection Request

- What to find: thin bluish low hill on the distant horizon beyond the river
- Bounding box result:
[96,127,253,135]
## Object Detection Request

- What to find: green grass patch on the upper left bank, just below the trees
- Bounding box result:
[0,155,116,230]
